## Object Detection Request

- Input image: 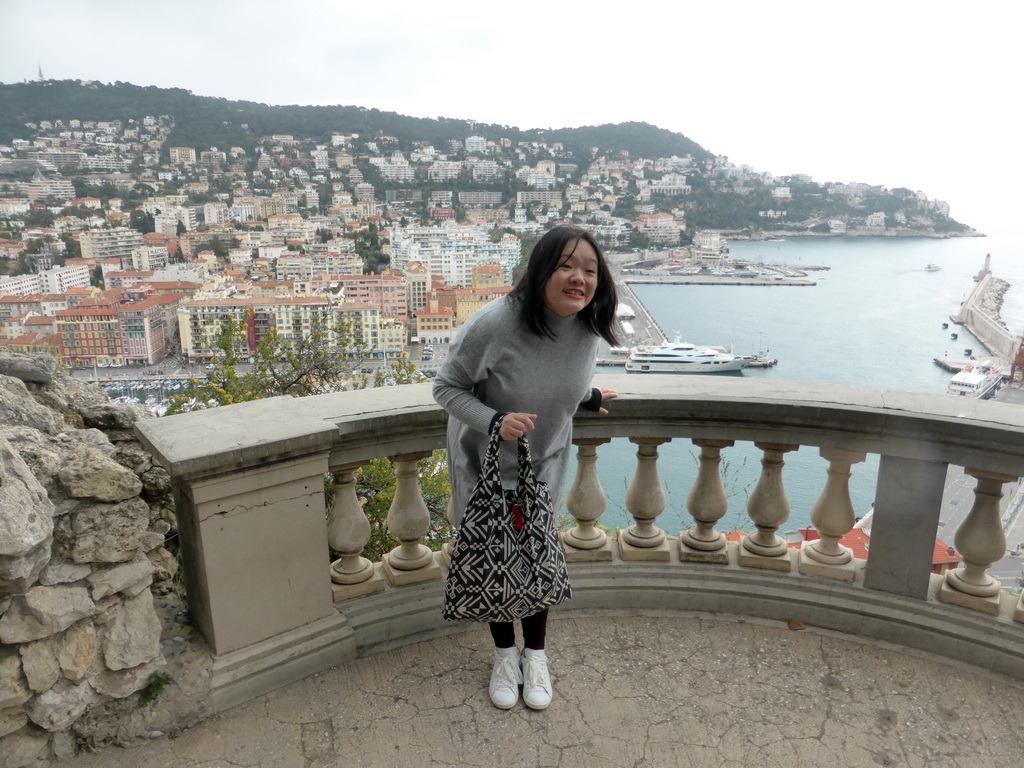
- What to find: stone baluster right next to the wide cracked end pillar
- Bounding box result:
[328,464,384,602]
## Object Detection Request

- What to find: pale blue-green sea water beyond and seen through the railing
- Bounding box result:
[598,238,1024,535]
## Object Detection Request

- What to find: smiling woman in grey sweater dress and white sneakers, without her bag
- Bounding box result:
[433,226,617,710]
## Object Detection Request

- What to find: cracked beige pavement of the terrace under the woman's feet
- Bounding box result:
[57,611,1024,768]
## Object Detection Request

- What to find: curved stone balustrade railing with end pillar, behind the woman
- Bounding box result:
[132,376,1024,708]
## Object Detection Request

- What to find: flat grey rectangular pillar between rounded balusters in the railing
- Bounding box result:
[864,456,947,600]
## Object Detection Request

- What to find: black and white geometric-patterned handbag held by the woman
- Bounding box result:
[441,422,572,622]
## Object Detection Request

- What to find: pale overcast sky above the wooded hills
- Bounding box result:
[0,0,1024,232]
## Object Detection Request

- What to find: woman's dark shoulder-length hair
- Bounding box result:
[509,226,618,346]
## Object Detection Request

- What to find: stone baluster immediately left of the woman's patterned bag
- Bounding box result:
[382,451,441,587]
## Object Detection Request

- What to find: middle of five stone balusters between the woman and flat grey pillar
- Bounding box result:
[679,438,735,563]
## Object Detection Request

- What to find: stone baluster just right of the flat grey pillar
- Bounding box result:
[939,467,1017,615]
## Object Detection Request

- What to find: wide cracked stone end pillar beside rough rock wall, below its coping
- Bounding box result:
[165,454,355,711]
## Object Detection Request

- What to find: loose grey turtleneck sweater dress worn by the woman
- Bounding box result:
[433,298,598,526]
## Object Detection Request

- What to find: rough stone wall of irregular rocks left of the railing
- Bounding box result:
[0,353,209,768]
